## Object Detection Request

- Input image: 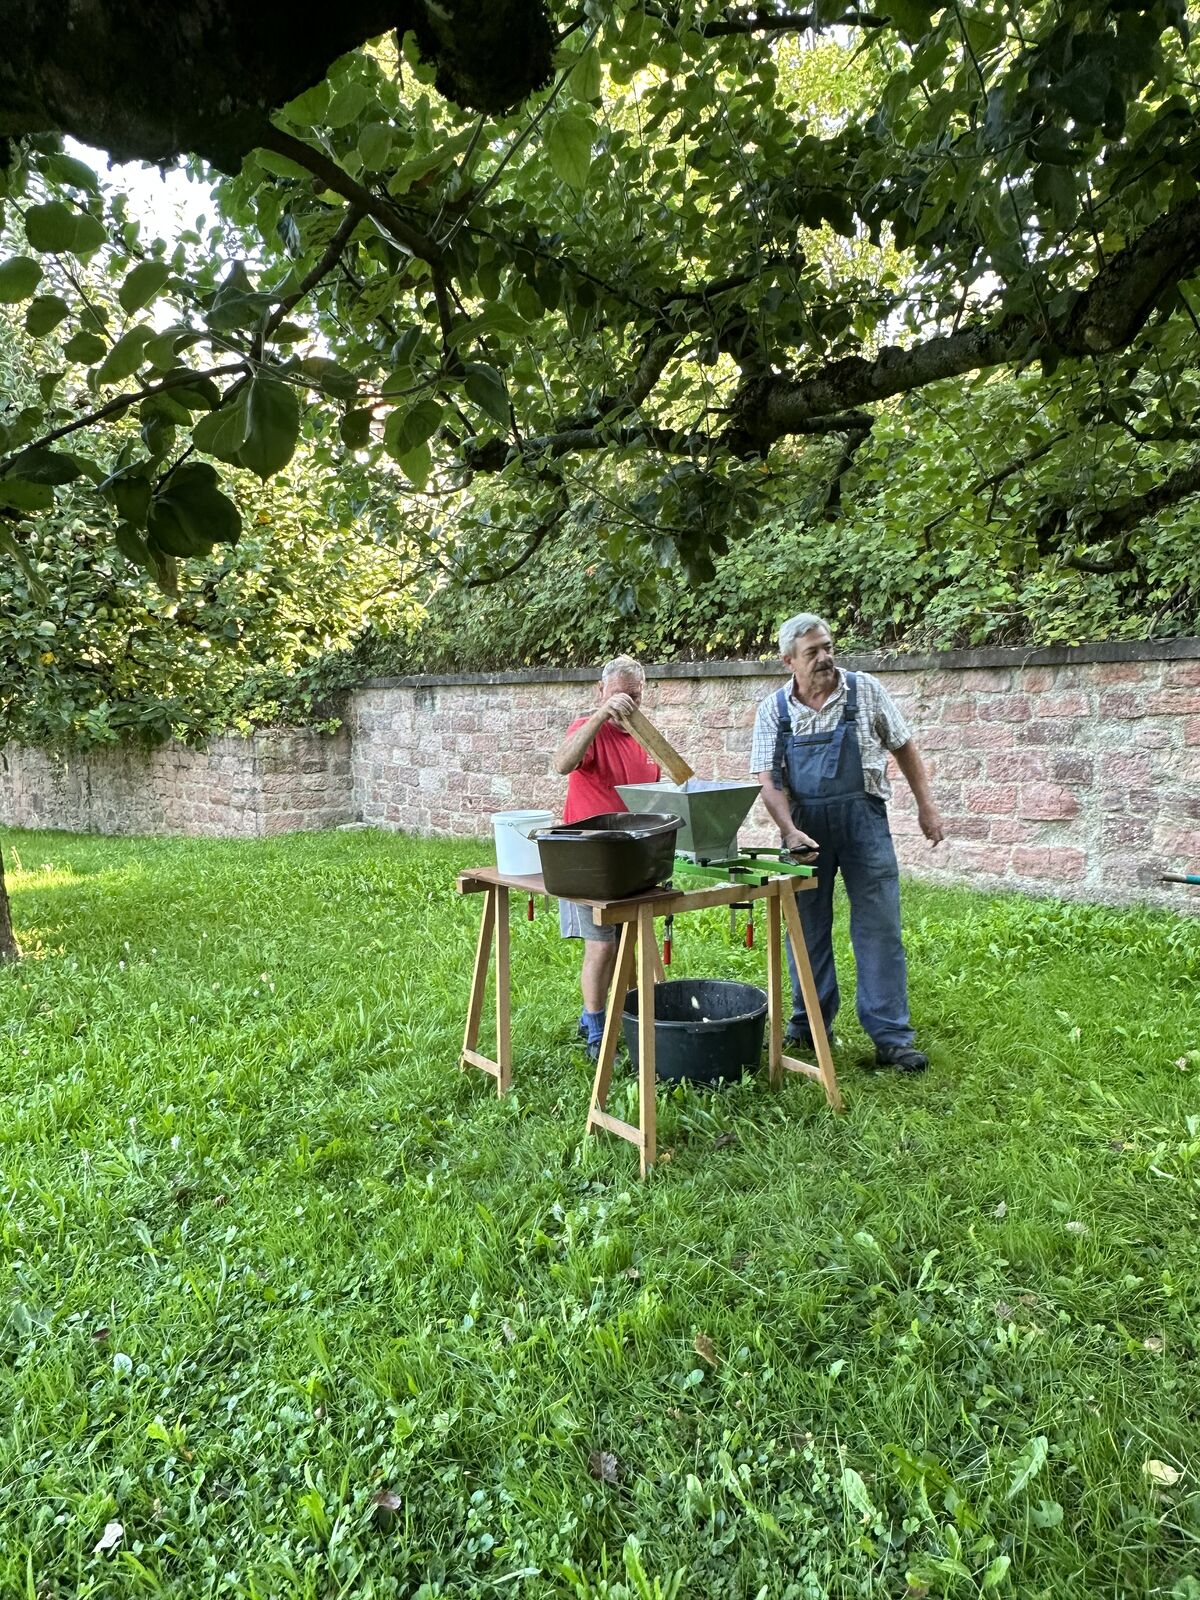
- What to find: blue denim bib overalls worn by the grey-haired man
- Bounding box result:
[771,672,912,1046]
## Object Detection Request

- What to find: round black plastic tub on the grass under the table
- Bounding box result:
[621,978,766,1085]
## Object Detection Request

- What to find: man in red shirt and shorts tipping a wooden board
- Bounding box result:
[554,656,659,1058]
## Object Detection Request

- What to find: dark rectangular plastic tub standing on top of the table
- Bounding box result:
[531,811,682,899]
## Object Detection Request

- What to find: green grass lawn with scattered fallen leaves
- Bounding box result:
[0,832,1200,1600]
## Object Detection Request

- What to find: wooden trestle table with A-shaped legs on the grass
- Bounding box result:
[458,867,843,1178]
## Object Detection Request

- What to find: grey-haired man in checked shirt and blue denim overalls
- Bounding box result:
[750,613,944,1072]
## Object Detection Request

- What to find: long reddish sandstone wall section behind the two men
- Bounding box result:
[350,640,1200,909]
